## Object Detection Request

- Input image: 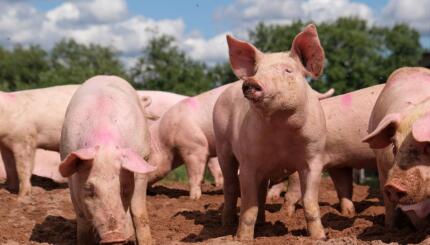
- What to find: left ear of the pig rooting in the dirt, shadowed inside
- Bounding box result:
[59,148,96,177]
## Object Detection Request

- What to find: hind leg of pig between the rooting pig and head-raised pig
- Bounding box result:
[181,148,208,200]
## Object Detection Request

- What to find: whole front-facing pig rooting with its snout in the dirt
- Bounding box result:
[59,76,155,244]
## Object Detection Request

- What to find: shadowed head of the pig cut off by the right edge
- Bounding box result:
[364,100,430,224]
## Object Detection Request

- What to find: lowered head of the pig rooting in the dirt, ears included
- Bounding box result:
[59,146,154,243]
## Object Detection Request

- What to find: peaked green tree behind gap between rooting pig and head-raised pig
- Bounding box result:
[131,36,213,95]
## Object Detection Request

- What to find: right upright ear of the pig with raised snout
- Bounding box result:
[290,24,324,78]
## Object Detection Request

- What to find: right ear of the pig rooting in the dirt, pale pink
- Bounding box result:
[121,149,156,174]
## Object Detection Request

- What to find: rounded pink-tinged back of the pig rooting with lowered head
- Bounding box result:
[62,76,149,154]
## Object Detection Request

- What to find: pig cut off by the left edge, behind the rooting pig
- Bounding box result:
[0,85,78,197]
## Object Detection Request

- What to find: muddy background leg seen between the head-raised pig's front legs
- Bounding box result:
[283,172,302,217]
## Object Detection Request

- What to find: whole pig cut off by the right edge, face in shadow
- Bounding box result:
[363,67,430,228]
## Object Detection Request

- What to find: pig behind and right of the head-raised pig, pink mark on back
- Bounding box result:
[267,84,384,216]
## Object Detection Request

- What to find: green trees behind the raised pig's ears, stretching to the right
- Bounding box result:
[250,18,423,94]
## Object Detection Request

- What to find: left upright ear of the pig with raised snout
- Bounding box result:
[227,35,262,79]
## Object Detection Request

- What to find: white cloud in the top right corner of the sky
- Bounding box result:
[382,0,430,35]
